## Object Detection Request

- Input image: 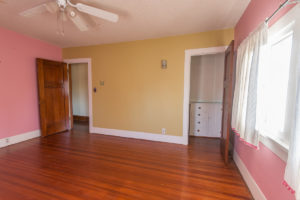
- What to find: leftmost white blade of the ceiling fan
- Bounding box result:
[19,1,58,17]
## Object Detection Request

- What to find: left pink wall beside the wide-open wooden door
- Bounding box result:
[0,28,62,139]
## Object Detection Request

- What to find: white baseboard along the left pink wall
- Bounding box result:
[0,130,41,148]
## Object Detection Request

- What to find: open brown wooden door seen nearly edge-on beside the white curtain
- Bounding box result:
[221,41,234,164]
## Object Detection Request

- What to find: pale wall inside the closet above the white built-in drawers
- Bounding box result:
[190,53,225,102]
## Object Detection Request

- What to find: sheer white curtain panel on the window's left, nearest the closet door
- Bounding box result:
[231,23,268,147]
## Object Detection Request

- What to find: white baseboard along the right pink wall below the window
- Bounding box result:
[233,151,267,200]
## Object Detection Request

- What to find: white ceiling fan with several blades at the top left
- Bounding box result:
[20,0,119,35]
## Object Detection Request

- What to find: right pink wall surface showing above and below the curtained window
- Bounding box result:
[235,0,295,200]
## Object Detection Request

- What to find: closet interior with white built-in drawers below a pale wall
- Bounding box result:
[189,54,224,137]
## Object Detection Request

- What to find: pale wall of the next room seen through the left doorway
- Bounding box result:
[71,63,89,116]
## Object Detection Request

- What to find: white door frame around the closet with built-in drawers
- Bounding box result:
[182,46,227,145]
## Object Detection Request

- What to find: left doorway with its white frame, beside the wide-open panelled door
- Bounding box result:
[64,58,93,132]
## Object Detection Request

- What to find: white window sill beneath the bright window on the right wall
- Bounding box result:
[259,135,289,162]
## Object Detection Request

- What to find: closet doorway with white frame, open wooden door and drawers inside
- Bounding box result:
[183,41,234,163]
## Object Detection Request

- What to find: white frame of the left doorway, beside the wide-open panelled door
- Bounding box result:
[64,58,93,132]
